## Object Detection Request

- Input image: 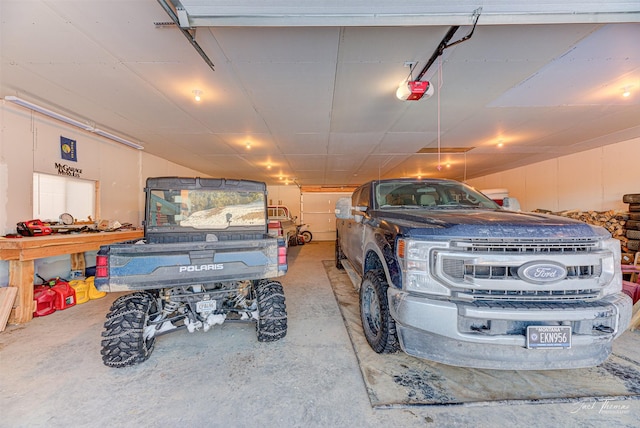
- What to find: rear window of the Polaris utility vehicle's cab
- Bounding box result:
[148,190,266,229]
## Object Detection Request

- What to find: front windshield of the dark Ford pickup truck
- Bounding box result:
[376,181,500,209]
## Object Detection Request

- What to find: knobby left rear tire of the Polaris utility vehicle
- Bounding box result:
[100,292,158,367]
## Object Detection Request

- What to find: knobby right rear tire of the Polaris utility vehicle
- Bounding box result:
[256,280,287,342]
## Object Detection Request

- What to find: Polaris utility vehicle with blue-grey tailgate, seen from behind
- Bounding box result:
[95,177,287,367]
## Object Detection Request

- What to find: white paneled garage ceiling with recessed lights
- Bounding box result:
[0,0,640,185]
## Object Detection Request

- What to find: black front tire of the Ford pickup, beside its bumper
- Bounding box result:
[360,269,399,354]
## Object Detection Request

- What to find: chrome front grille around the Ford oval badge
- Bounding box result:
[437,239,603,302]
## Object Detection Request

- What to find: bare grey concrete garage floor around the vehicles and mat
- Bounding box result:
[0,242,640,427]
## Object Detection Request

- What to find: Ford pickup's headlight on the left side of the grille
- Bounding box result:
[396,238,451,296]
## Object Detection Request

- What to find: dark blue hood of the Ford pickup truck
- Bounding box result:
[373,208,609,239]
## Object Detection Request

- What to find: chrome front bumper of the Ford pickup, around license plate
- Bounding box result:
[388,288,632,370]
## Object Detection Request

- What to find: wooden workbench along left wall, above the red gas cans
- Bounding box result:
[0,230,144,324]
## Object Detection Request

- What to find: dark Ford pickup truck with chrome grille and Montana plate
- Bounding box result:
[335,179,632,370]
